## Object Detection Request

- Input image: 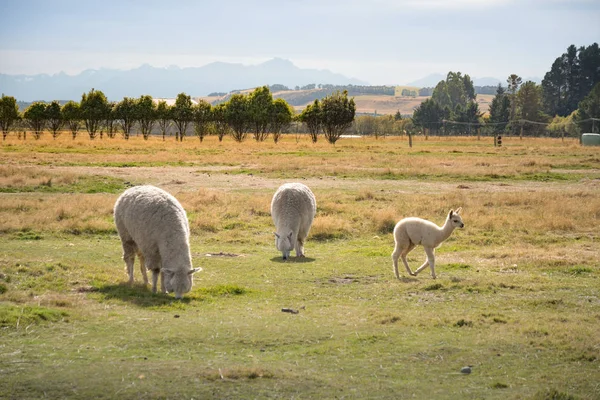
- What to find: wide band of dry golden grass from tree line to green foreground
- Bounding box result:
[0,137,600,241]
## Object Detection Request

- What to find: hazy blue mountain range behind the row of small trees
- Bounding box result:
[0,58,366,101]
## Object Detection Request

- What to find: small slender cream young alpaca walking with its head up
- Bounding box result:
[392,207,465,279]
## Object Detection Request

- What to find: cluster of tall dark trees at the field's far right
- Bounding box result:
[413,43,600,136]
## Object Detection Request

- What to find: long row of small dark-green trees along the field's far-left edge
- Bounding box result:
[0,86,356,143]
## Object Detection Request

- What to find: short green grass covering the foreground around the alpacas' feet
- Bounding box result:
[0,236,600,398]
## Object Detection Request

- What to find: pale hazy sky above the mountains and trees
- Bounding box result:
[0,0,600,84]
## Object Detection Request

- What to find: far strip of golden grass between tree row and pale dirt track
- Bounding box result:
[1,135,600,177]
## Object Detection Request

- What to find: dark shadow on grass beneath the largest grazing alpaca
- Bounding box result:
[94,283,190,307]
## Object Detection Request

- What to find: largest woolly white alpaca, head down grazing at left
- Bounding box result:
[114,186,202,299]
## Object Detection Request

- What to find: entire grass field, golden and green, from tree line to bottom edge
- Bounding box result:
[0,134,600,399]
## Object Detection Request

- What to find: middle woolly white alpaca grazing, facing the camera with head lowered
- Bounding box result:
[271,183,317,260]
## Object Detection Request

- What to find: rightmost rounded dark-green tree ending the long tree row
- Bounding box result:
[321,90,356,144]
